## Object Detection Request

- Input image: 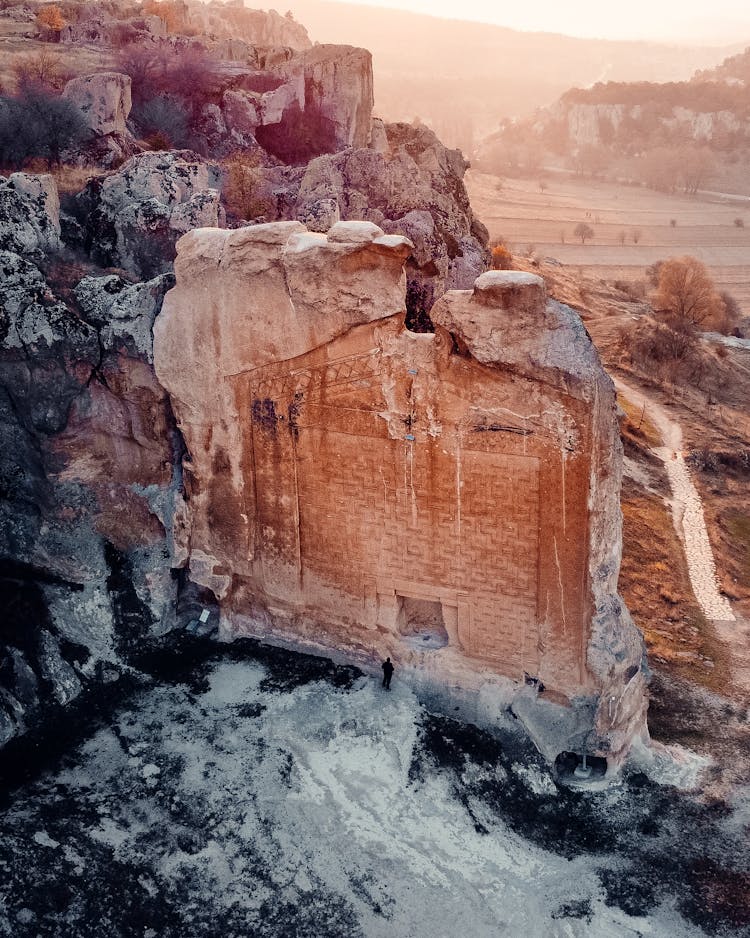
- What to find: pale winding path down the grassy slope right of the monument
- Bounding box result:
[614,378,735,622]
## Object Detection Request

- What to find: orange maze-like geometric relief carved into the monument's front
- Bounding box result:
[247,351,540,671]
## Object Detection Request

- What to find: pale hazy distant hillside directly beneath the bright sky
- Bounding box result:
[288,0,750,154]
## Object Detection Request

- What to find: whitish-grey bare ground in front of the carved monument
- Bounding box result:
[0,661,744,938]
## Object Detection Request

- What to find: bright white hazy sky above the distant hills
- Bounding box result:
[326,0,750,42]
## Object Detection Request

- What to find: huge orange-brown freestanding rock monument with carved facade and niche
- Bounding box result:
[154,222,645,764]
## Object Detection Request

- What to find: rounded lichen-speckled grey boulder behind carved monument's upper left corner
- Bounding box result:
[78,150,224,279]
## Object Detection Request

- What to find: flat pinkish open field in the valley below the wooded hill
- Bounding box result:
[467,172,750,315]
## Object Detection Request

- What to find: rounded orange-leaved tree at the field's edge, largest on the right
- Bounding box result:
[655,257,726,329]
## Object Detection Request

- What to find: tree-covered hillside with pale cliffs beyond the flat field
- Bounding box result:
[479,50,750,194]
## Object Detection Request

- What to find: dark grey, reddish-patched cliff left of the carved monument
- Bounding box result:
[0,174,181,745]
